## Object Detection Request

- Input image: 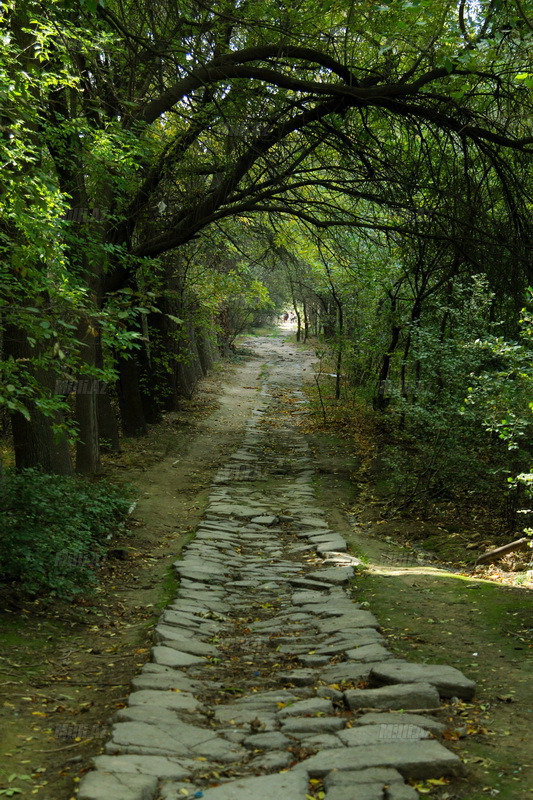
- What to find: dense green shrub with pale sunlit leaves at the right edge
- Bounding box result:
[378,277,533,504]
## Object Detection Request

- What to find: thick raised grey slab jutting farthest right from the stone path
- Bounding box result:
[370,660,476,700]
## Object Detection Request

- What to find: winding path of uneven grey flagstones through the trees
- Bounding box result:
[78,340,475,800]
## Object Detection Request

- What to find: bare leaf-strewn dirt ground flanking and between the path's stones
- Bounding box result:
[0,337,532,800]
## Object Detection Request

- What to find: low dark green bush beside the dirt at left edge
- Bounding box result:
[0,469,130,598]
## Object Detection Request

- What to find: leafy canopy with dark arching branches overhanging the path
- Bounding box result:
[6,0,533,256]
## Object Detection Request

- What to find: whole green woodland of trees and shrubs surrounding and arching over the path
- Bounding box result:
[0,0,533,592]
